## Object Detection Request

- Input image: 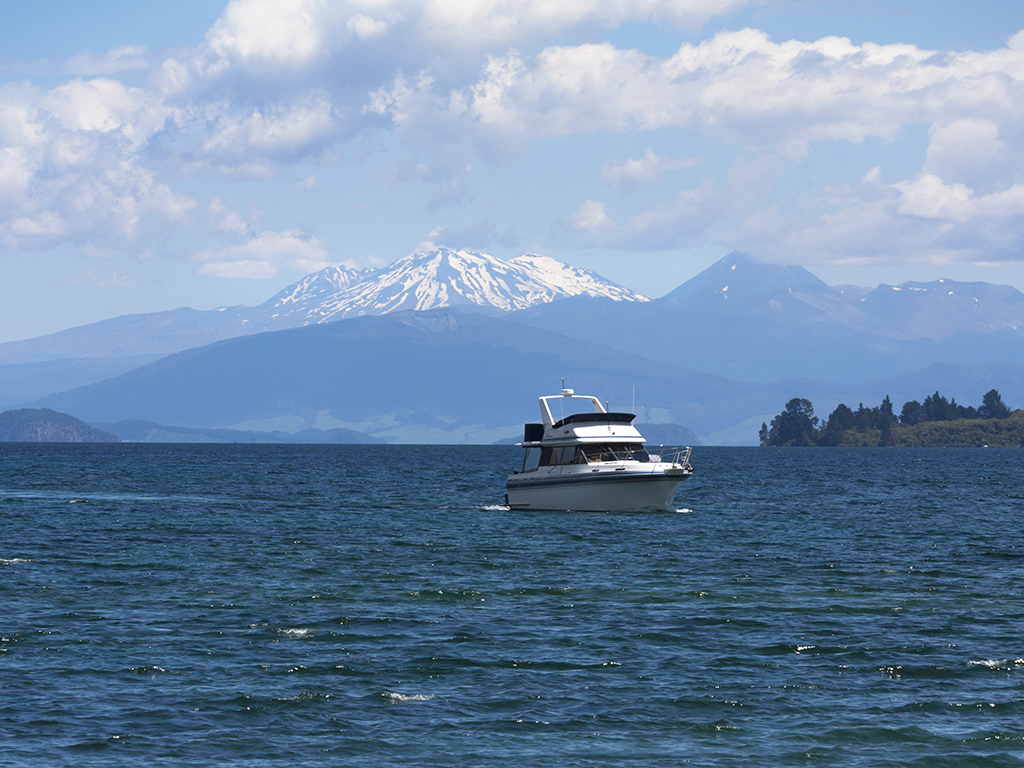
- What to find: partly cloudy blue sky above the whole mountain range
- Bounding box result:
[0,0,1024,342]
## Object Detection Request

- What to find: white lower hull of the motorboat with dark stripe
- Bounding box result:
[505,469,690,512]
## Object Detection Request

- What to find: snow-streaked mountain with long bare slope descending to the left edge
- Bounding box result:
[0,248,647,407]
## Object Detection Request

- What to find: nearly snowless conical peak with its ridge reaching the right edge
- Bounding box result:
[510,253,1024,384]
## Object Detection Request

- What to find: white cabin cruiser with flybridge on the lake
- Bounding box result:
[505,389,693,512]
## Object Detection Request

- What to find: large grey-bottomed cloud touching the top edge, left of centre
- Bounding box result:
[148,0,762,169]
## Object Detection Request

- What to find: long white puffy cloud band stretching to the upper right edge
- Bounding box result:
[430,30,1024,156]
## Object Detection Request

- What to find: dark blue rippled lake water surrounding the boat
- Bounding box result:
[0,444,1024,768]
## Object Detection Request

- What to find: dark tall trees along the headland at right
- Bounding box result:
[758,389,1011,446]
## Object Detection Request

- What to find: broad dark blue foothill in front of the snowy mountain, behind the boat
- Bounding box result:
[28,308,1024,444]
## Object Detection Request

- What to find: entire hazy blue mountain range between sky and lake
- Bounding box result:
[9,249,1024,444]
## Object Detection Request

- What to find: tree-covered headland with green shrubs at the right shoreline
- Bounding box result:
[759,389,1024,447]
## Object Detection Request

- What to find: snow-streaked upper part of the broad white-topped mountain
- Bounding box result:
[258,248,648,325]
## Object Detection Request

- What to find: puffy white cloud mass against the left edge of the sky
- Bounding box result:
[0,79,195,250]
